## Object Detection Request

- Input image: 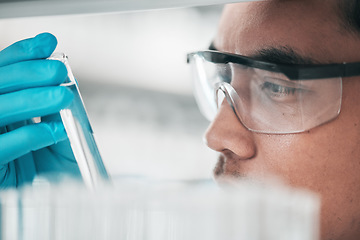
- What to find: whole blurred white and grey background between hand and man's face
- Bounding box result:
[0,5,222,180]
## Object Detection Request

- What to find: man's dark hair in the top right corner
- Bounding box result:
[338,0,360,34]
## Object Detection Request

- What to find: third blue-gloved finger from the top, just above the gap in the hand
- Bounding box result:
[0,86,74,126]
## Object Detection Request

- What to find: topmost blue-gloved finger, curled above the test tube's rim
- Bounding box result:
[0,33,57,67]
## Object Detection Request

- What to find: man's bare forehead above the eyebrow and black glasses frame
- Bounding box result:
[215,0,359,63]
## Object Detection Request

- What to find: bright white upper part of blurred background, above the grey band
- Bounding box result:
[0,7,220,94]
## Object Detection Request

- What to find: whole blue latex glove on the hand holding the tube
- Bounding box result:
[0,33,80,188]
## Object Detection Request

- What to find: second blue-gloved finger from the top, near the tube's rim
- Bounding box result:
[0,60,67,94]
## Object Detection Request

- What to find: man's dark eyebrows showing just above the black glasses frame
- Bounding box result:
[209,43,319,64]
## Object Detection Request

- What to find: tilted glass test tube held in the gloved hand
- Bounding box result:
[49,53,110,189]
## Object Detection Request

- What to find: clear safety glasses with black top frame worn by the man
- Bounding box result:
[187,51,360,134]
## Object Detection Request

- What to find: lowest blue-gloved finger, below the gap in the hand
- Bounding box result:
[0,122,67,164]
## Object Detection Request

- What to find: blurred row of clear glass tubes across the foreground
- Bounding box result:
[0,179,321,240]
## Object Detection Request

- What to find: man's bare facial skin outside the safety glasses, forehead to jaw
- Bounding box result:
[205,0,360,240]
